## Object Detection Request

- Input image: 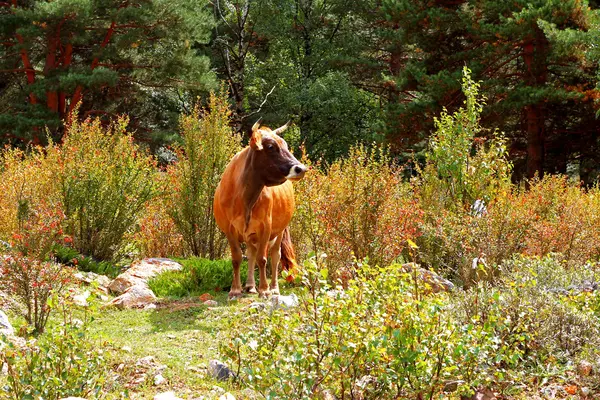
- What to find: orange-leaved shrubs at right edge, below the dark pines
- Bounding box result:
[419,176,600,285]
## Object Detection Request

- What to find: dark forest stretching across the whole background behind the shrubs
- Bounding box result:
[0,0,600,184]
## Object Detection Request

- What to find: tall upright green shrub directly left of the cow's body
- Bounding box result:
[166,93,241,259]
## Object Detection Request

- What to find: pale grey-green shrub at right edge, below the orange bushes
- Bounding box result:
[452,255,600,366]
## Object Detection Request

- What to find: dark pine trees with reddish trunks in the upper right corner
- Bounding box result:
[349,0,599,181]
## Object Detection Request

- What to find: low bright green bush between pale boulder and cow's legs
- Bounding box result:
[148,258,248,298]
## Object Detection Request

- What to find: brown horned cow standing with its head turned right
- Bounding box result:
[214,120,307,298]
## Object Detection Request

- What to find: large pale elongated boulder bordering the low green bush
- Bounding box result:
[108,258,183,294]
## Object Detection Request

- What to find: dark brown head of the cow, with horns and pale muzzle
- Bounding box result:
[250,120,308,186]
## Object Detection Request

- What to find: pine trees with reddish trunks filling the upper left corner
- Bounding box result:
[0,0,213,143]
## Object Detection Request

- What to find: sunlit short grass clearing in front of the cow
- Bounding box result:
[90,292,244,399]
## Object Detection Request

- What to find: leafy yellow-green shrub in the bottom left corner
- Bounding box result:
[0,306,112,400]
